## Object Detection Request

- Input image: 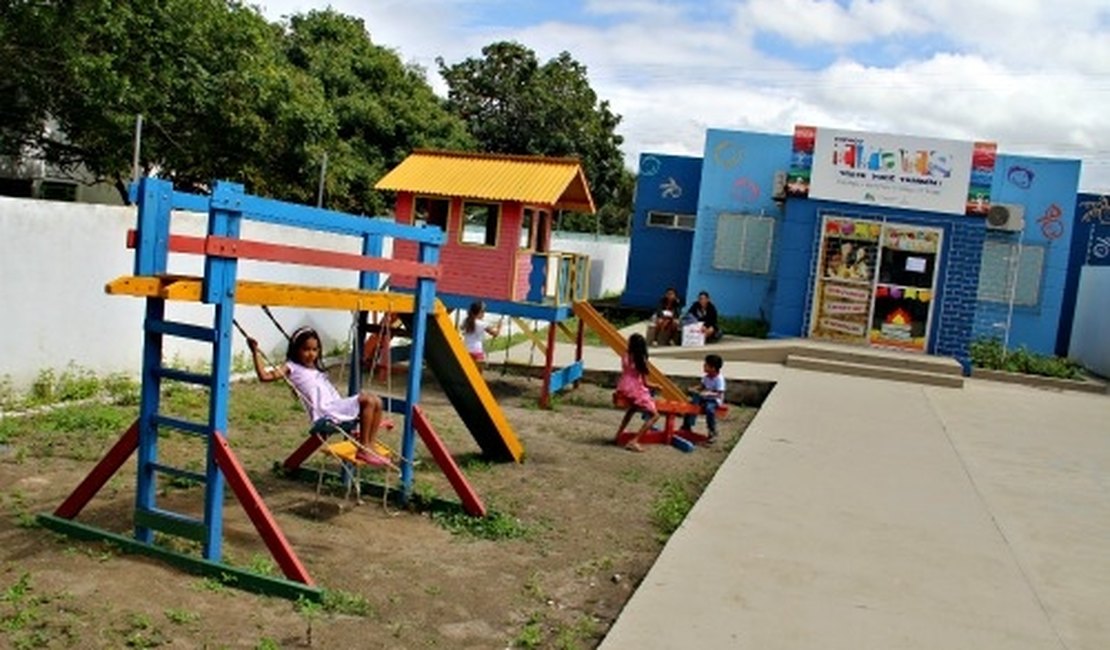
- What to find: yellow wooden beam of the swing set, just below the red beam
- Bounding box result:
[104,275,446,314]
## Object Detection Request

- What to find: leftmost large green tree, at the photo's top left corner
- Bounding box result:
[0,0,334,201]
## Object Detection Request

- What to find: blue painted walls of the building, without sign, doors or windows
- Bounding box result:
[624,130,1083,368]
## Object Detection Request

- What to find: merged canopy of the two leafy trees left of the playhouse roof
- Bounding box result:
[0,0,472,213]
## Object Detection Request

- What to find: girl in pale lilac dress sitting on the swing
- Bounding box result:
[246,327,390,467]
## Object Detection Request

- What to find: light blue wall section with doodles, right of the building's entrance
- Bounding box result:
[973,154,1080,354]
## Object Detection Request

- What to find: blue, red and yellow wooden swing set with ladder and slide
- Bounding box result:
[40,177,523,599]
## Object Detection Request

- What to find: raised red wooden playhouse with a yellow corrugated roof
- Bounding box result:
[375,150,594,406]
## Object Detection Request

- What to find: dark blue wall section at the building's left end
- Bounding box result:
[620,153,702,307]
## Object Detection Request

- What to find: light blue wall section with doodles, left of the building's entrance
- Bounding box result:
[687,129,794,318]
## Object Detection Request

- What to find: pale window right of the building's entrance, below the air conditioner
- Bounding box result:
[979,240,1045,307]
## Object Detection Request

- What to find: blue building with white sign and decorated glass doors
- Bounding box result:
[624,126,1080,367]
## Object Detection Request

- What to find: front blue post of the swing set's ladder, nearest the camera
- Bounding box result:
[202,181,243,561]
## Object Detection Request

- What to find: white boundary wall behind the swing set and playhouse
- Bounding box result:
[0,196,628,390]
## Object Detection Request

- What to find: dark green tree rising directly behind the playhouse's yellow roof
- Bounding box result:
[436,41,632,233]
